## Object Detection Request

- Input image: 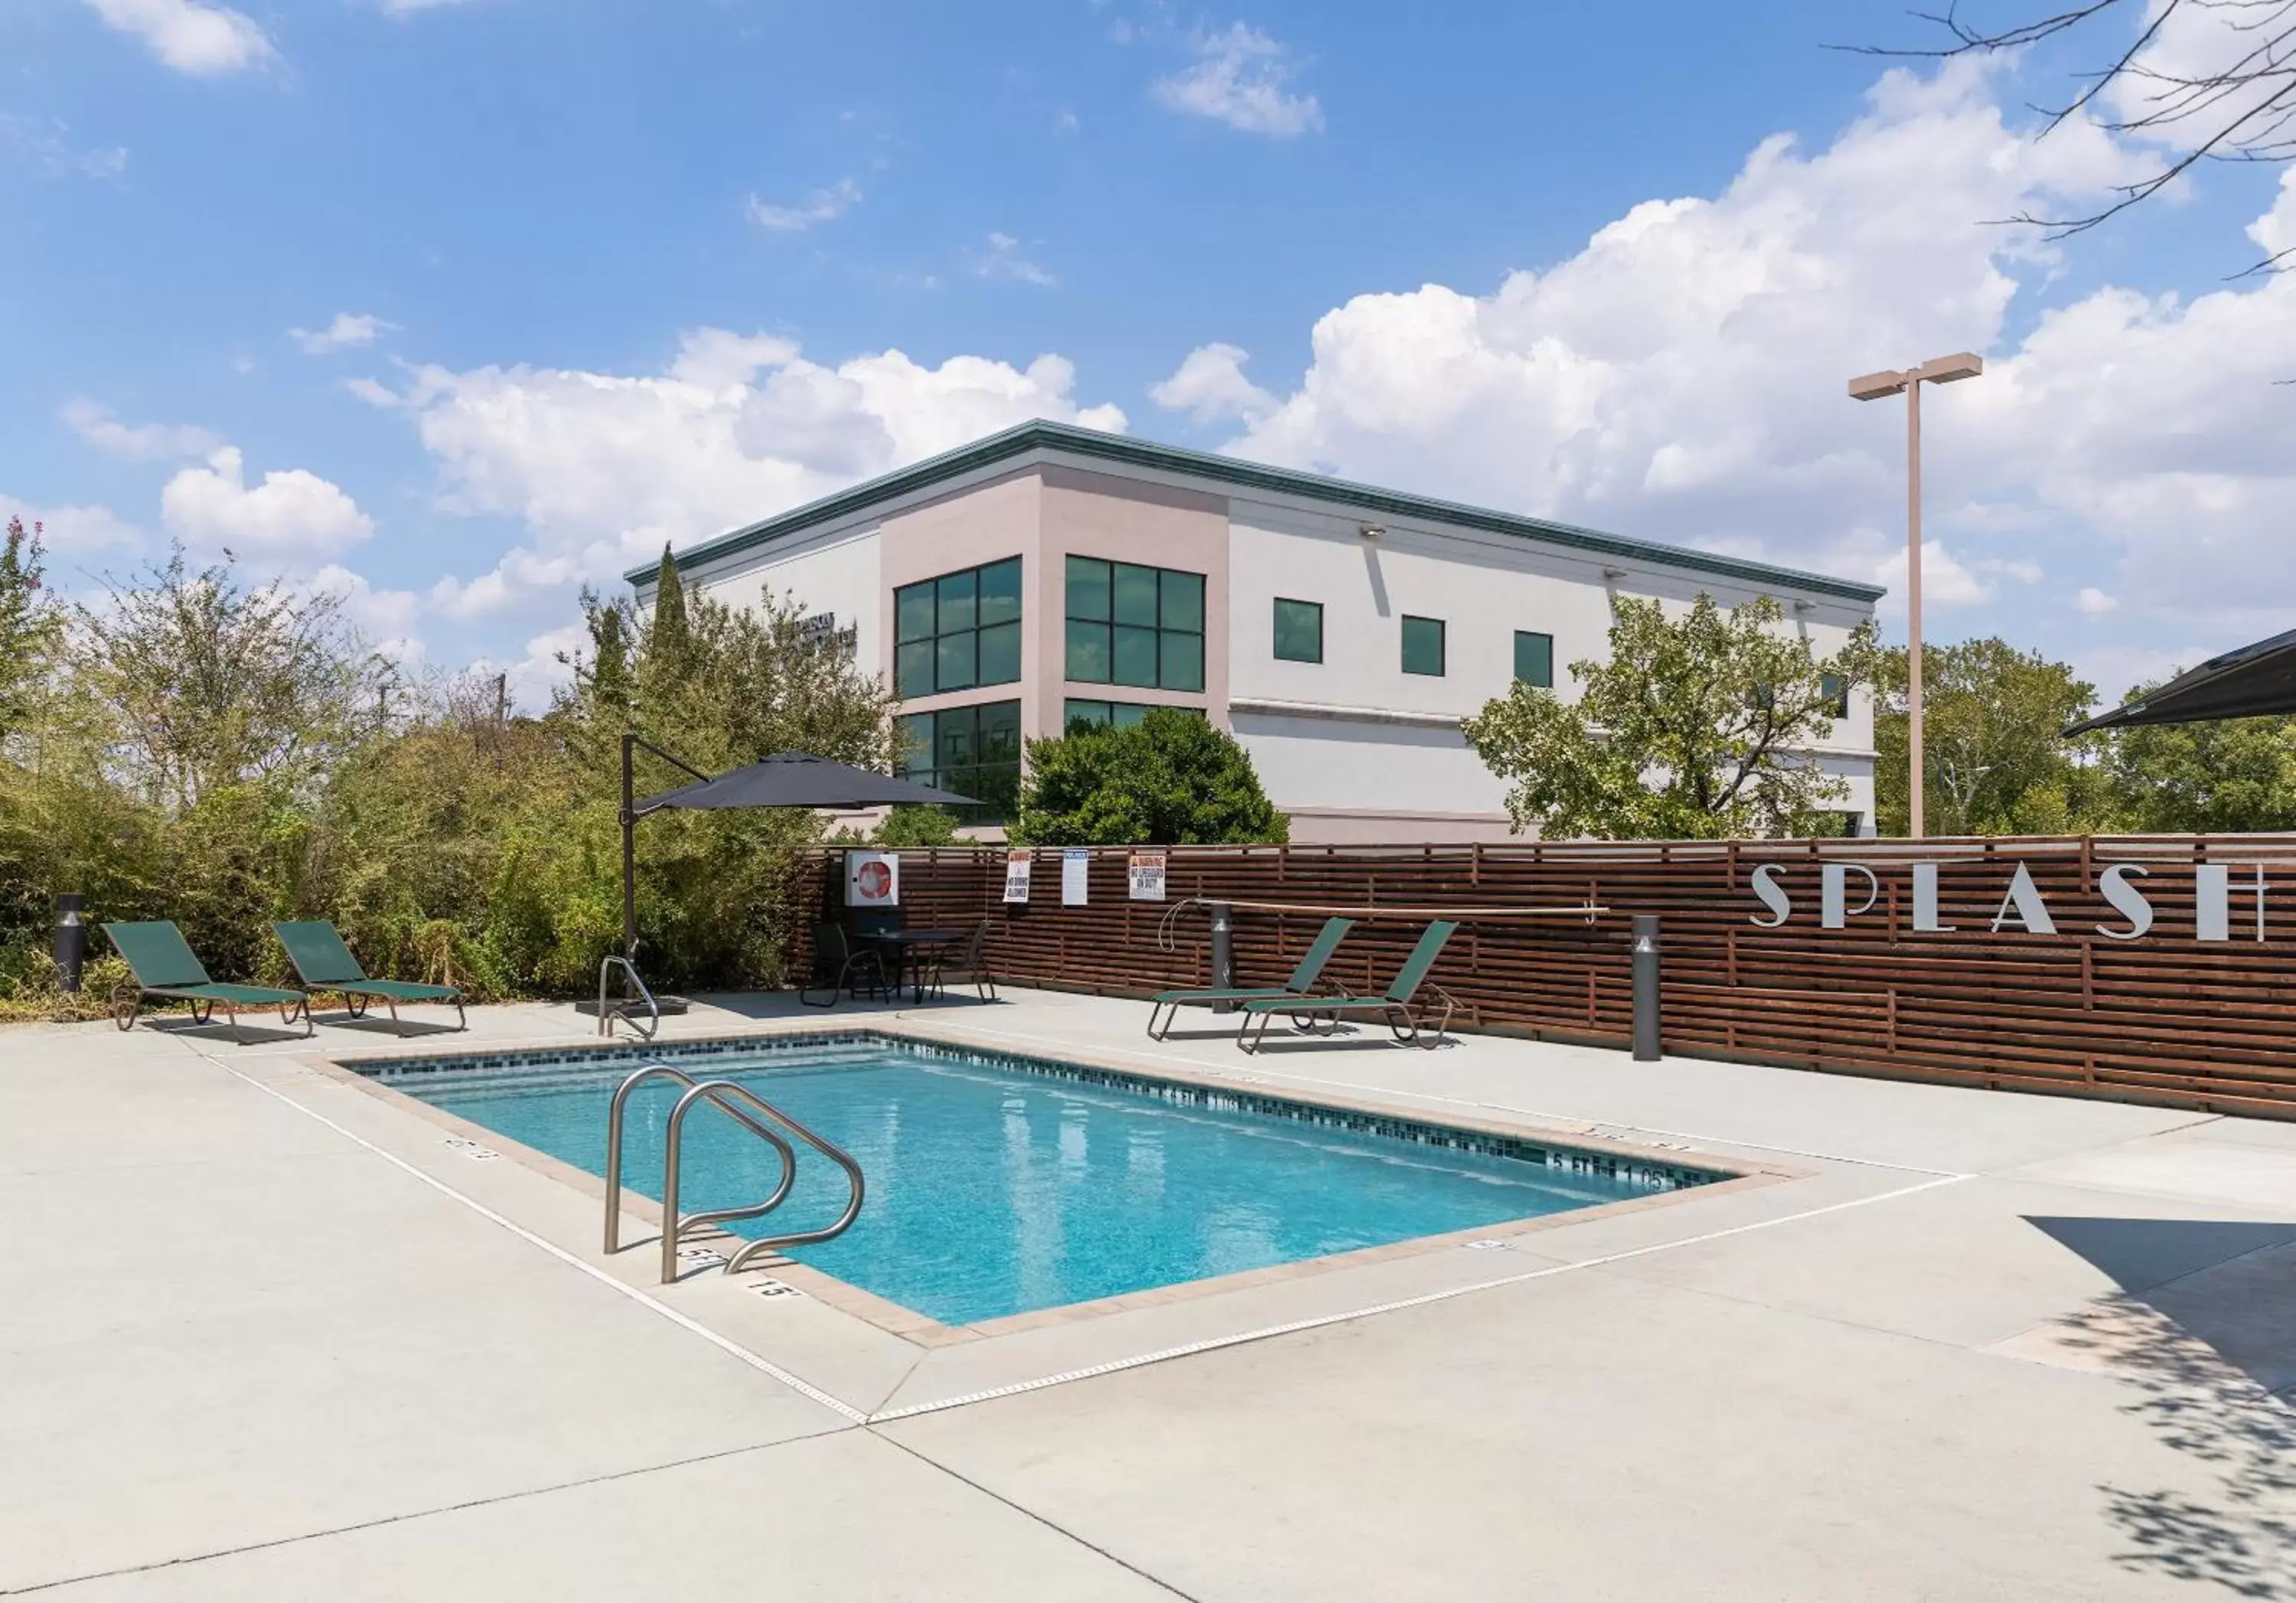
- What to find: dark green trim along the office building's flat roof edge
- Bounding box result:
[622,418,1883,602]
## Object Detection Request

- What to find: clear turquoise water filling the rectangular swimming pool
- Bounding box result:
[393,1043,1704,1325]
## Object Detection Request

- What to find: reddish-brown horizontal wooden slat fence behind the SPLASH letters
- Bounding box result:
[801,836,2296,1118]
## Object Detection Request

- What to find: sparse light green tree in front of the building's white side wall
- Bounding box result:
[1460,595,1874,841]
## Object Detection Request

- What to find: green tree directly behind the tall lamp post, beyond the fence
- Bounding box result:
[1874,636,2112,836]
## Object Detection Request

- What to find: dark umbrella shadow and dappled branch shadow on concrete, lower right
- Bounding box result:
[2027,1217,2296,1598]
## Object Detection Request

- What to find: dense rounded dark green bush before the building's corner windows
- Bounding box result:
[1013,707,1290,845]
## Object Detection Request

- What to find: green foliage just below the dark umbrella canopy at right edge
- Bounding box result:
[2105,684,2296,834]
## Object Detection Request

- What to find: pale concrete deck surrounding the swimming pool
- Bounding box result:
[0,992,2296,1603]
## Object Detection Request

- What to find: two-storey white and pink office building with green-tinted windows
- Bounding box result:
[629,423,1880,841]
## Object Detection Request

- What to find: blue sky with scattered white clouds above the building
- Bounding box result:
[0,0,2296,698]
